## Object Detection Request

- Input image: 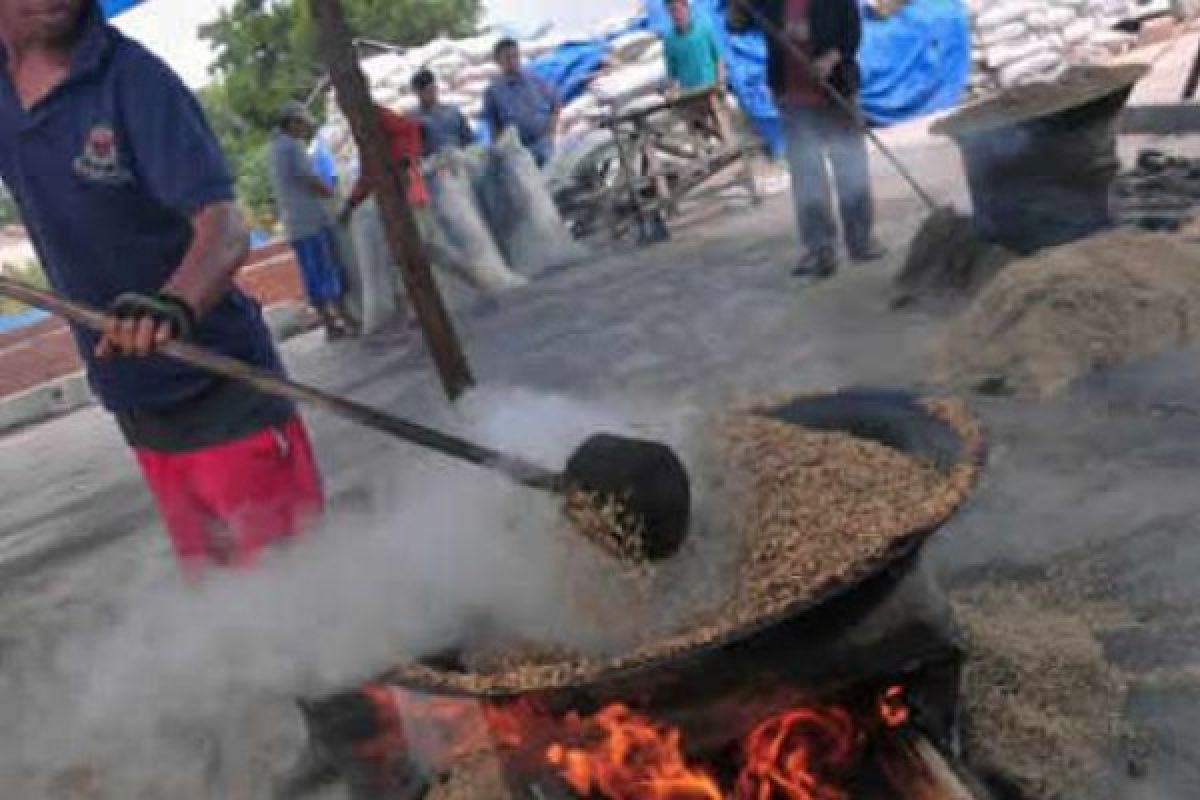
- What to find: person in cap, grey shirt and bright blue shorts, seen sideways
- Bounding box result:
[266,102,355,339]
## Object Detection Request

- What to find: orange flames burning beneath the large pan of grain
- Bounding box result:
[348,686,910,800]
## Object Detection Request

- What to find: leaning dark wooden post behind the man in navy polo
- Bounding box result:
[308,0,475,401]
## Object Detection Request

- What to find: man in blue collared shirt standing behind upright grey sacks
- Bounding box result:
[484,38,563,167]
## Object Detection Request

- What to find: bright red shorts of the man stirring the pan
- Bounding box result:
[134,416,324,573]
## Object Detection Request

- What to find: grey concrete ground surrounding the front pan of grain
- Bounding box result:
[7,35,1200,800]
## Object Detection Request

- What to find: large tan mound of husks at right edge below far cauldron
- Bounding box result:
[940,230,1200,396]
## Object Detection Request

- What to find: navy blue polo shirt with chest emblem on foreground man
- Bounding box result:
[0,6,280,413]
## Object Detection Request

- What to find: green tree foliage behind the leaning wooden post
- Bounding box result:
[200,0,481,225]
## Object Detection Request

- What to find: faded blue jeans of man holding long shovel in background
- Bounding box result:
[780,106,875,253]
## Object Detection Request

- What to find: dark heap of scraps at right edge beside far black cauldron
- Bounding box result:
[1112,150,1200,233]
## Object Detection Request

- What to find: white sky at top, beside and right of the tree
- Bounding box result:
[116,0,637,88]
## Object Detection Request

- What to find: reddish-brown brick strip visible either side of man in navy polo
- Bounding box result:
[0,243,304,397]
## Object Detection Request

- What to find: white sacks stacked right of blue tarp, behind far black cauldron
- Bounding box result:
[967,0,1128,95]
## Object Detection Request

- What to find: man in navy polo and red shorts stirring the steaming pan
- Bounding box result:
[0,0,323,575]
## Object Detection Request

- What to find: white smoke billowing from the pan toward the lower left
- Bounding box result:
[0,392,720,800]
